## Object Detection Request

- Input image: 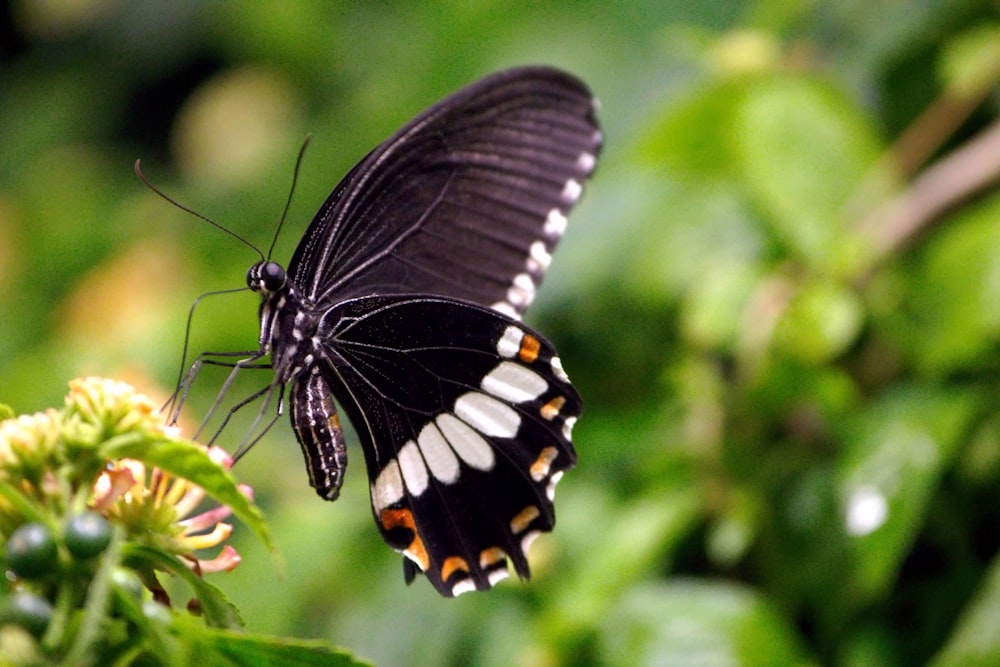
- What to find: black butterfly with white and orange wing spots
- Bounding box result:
[237,67,601,596]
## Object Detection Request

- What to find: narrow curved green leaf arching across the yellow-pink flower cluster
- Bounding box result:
[102,433,273,549]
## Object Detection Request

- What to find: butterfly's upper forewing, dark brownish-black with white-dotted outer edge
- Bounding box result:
[288,67,601,317]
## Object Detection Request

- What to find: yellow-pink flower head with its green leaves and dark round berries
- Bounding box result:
[0,378,269,666]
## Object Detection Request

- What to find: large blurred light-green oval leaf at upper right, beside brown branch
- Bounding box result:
[729,76,879,277]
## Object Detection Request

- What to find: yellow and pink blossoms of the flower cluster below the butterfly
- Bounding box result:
[0,378,252,573]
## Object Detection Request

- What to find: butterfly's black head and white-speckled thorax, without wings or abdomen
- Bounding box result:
[247,261,320,384]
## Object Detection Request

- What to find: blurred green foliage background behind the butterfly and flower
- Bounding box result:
[0,0,1000,667]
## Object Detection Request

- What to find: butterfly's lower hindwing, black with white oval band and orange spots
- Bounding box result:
[307,295,581,596]
